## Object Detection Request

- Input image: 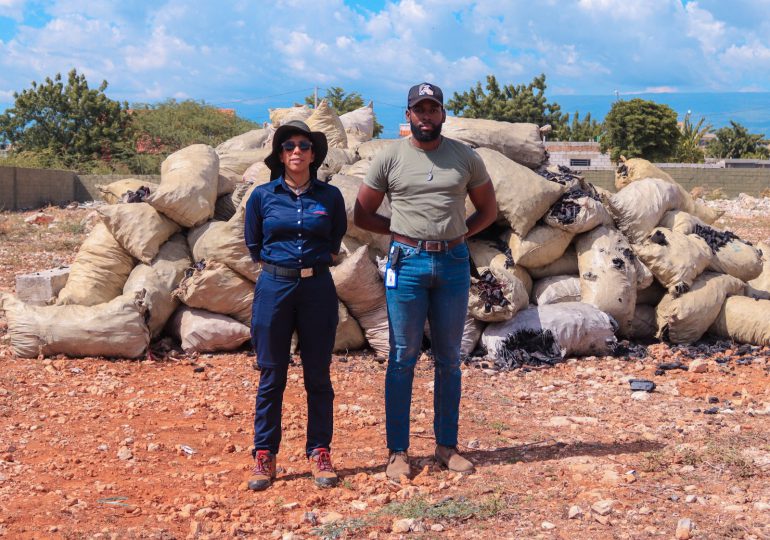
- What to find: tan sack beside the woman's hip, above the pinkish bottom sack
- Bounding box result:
[172,261,254,327]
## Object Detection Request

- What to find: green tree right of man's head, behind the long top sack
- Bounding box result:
[446,74,569,140]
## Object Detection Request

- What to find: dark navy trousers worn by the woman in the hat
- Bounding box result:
[251,271,339,455]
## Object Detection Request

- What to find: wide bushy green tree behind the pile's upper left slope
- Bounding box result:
[127,99,259,174]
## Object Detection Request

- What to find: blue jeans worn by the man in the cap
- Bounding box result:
[385,242,470,452]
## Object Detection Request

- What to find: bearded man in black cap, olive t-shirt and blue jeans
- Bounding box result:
[354,83,497,480]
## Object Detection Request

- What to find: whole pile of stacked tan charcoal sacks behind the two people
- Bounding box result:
[0,102,770,366]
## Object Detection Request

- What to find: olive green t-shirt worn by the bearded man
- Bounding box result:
[364,137,489,240]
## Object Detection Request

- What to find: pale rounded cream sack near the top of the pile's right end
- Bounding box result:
[609,178,682,244]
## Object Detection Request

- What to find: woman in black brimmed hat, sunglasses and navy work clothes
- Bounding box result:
[245,121,347,490]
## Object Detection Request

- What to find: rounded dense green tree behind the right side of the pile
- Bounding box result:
[601,98,680,161]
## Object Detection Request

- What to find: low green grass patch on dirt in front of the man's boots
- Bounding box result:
[378,496,505,520]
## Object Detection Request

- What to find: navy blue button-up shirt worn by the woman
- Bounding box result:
[245,176,347,268]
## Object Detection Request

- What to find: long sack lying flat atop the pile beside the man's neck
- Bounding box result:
[441,116,546,169]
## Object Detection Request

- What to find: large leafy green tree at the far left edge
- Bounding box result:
[0,69,130,170]
